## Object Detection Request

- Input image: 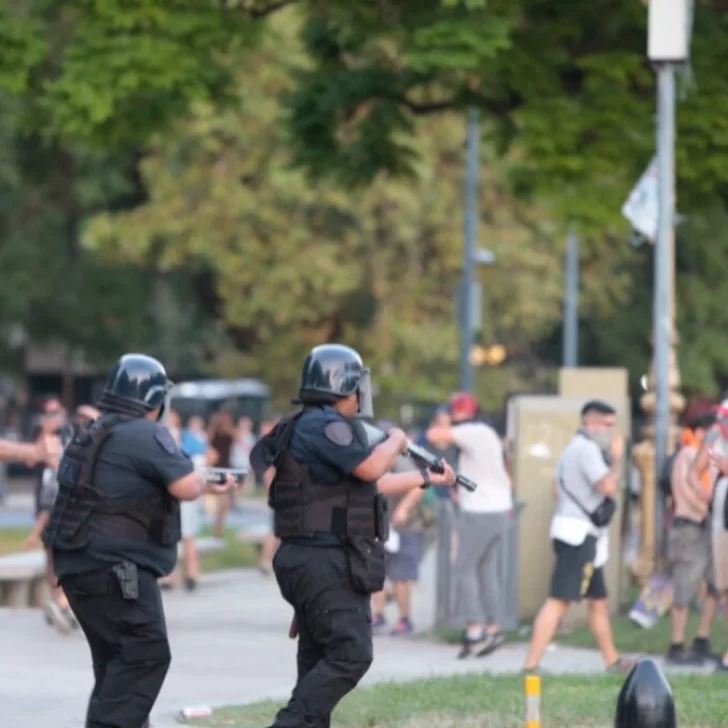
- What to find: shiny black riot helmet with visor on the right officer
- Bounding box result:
[298,344,374,417]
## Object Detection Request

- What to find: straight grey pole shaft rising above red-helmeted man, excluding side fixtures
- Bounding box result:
[460,108,478,392]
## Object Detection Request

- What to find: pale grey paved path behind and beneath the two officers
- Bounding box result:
[0,516,708,728]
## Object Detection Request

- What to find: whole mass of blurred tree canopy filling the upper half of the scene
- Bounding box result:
[0,0,728,410]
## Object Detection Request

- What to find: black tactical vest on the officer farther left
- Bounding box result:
[43,414,181,551]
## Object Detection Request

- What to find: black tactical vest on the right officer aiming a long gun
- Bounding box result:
[268,413,389,542]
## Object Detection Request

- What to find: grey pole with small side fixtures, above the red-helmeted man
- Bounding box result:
[458,107,495,392]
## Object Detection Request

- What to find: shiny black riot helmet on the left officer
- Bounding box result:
[99,354,173,419]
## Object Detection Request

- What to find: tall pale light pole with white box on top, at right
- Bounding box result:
[647,0,692,555]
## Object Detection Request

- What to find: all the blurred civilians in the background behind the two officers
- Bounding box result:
[12,386,728,671]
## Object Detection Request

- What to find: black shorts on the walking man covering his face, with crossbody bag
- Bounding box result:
[549,536,607,602]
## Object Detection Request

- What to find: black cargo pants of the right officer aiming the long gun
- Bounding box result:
[273,542,373,728]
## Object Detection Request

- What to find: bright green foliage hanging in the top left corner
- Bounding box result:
[0,0,255,147]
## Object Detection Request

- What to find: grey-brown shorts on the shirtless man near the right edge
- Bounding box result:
[667,517,715,607]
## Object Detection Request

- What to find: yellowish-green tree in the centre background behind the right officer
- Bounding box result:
[85,13,644,406]
